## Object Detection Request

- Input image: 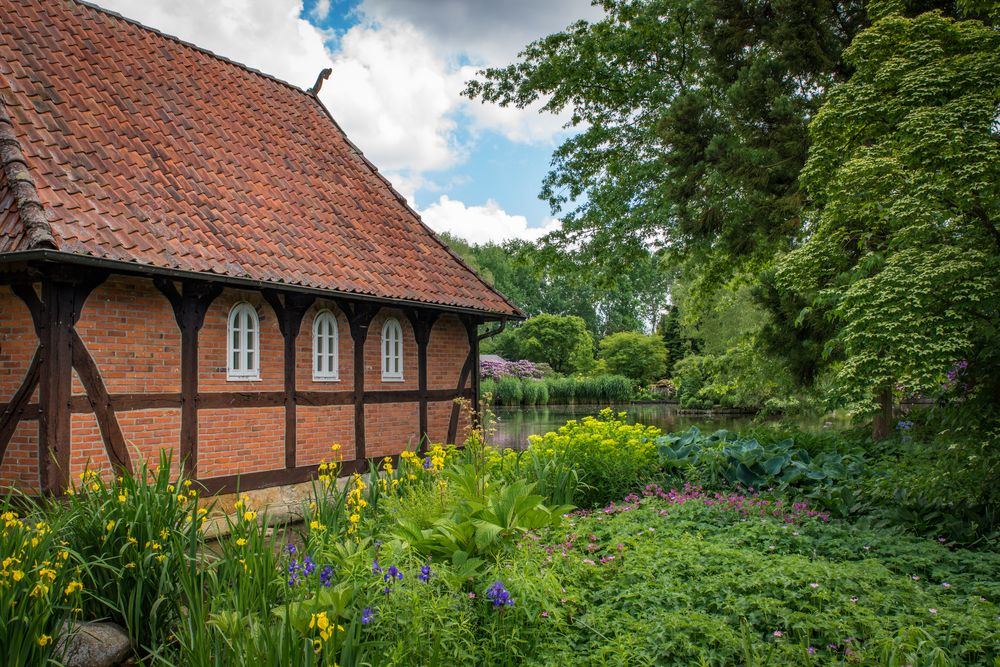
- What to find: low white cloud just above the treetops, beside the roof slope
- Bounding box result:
[420,195,559,243]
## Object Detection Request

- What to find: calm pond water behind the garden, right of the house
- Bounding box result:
[491,403,844,449]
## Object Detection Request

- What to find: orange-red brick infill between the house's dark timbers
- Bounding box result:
[0,276,470,490]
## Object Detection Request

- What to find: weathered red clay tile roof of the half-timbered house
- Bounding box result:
[0,0,520,317]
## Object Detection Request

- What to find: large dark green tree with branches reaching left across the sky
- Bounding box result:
[465,0,865,282]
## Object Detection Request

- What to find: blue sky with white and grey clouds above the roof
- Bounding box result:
[97,0,599,242]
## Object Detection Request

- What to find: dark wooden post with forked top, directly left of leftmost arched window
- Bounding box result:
[153,278,222,477]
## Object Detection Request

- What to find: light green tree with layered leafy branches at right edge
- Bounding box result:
[776,9,1000,438]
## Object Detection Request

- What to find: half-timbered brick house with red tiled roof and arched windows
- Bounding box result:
[0,0,522,492]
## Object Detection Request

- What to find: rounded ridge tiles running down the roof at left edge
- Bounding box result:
[0,84,56,250]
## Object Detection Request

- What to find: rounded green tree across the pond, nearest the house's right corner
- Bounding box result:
[506,313,594,373]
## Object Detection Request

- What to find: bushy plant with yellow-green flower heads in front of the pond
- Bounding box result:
[529,409,660,507]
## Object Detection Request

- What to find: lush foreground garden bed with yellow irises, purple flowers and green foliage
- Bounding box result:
[0,411,1000,666]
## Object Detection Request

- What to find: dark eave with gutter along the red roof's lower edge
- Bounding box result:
[0,249,526,321]
